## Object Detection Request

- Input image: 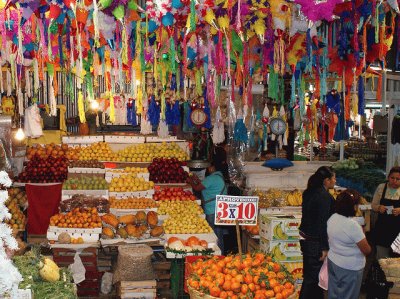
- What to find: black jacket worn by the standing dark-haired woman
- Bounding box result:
[300,187,334,250]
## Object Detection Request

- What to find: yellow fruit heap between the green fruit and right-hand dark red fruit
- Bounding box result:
[109,174,154,192]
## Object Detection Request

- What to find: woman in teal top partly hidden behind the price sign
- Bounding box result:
[188,163,228,254]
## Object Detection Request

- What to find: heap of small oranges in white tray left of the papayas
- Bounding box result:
[50,208,101,228]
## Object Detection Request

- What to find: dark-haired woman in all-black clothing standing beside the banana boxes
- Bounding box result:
[300,166,336,299]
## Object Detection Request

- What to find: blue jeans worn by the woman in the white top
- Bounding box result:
[328,259,364,299]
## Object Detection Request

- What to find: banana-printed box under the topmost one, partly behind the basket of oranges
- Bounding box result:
[260,238,303,262]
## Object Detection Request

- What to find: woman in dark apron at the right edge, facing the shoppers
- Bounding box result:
[371,167,400,259]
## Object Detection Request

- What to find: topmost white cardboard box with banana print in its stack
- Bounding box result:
[260,215,301,241]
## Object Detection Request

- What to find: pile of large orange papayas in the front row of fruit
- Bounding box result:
[101,211,164,239]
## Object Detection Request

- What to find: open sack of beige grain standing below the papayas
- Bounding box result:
[113,244,155,284]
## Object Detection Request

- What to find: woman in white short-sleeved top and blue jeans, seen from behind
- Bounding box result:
[328,190,371,299]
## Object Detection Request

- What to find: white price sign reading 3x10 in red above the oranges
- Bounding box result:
[214,195,258,225]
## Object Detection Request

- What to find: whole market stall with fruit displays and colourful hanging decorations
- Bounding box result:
[0,0,400,299]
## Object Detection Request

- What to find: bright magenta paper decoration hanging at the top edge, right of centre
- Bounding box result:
[294,0,343,22]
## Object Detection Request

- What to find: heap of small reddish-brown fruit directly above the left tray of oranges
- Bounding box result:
[60,194,110,213]
